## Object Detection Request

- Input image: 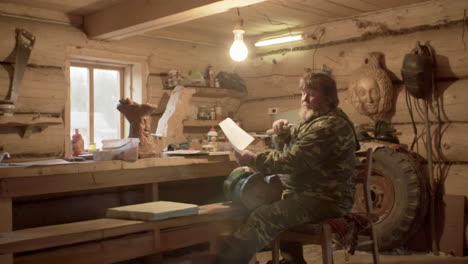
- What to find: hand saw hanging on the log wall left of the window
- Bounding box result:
[0,28,36,115]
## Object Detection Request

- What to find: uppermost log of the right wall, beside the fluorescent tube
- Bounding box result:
[253,0,468,56]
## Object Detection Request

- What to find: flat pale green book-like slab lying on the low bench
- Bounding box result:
[106,201,199,221]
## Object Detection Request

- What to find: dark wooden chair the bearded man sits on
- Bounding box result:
[272,149,380,264]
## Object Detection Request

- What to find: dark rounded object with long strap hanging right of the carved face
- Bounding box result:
[401,41,439,255]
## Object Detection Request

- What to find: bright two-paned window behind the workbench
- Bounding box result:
[70,63,124,148]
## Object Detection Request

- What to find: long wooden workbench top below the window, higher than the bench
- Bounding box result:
[0,155,237,262]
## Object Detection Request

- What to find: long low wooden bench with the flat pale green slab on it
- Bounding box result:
[0,204,242,264]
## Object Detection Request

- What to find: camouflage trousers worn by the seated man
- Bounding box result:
[233,193,351,253]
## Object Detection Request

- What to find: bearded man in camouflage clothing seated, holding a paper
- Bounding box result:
[217,73,359,264]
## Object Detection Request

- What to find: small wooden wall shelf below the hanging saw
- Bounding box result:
[0,115,62,138]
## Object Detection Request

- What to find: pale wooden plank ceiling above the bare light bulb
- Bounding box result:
[0,0,427,45]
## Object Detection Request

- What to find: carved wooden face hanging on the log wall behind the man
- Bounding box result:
[349,53,394,121]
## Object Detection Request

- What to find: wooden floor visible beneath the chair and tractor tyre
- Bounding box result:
[257,245,468,264]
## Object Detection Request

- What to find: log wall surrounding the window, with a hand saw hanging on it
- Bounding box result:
[0,12,232,161]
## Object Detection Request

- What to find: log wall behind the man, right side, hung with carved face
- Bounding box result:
[237,1,468,196]
